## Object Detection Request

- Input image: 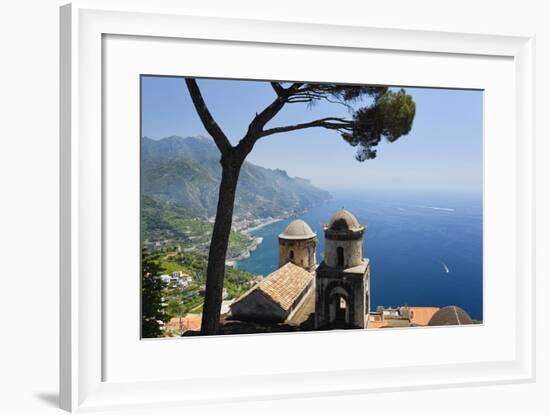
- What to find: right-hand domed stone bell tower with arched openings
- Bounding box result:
[315,209,370,328]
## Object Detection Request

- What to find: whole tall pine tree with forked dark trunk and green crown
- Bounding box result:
[185,78,416,334]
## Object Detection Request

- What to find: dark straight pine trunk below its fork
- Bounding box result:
[201,158,242,334]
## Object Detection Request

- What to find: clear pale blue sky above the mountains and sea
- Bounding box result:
[142,76,483,193]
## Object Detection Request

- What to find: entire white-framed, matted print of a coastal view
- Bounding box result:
[61,3,534,411]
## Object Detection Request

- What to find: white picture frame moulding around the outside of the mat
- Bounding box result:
[60,1,535,411]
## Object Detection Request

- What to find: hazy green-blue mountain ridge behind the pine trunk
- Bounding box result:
[141,136,331,220]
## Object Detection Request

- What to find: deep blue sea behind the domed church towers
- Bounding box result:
[236,193,483,320]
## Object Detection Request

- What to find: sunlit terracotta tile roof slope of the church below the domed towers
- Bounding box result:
[257,262,313,310]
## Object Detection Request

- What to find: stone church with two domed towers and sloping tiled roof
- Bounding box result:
[230,209,370,329]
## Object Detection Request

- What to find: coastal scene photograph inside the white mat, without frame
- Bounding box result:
[141,74,484,339]
